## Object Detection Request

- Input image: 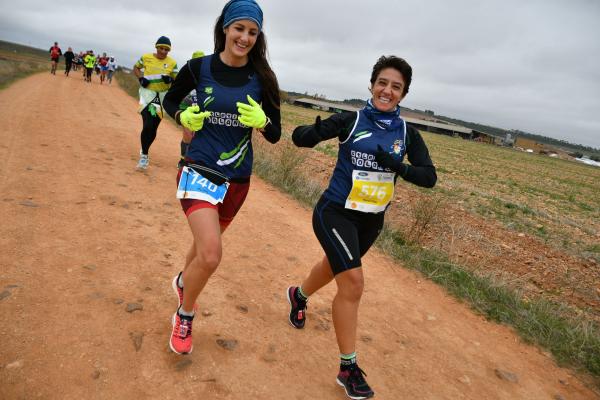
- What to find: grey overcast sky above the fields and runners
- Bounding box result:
[0,0,600,148]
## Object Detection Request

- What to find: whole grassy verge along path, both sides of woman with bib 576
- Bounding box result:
[254,140,600,385]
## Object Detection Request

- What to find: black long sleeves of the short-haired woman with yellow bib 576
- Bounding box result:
[292,112,437,188]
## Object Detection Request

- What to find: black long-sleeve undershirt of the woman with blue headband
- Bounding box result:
[163,54,281,143]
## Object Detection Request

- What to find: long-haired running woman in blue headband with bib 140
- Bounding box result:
[164,0,281,354]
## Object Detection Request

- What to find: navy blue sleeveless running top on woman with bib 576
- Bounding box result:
[323,109,406,206]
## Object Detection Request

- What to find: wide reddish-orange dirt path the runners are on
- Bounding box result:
[0,74,600,400]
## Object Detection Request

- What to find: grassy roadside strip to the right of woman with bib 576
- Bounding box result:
[377,228,600,385]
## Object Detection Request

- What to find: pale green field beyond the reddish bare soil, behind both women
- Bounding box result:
[282,105,600,261]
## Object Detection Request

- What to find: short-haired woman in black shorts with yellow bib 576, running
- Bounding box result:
[287,56,437,399]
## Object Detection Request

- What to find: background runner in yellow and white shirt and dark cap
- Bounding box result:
[133,36,177,170]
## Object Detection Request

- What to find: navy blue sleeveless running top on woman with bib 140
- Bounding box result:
[186,54,262,178]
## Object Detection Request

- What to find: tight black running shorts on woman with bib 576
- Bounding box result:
[313,197,385,275]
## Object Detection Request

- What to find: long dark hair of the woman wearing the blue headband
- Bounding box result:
[214,13,280,108]
